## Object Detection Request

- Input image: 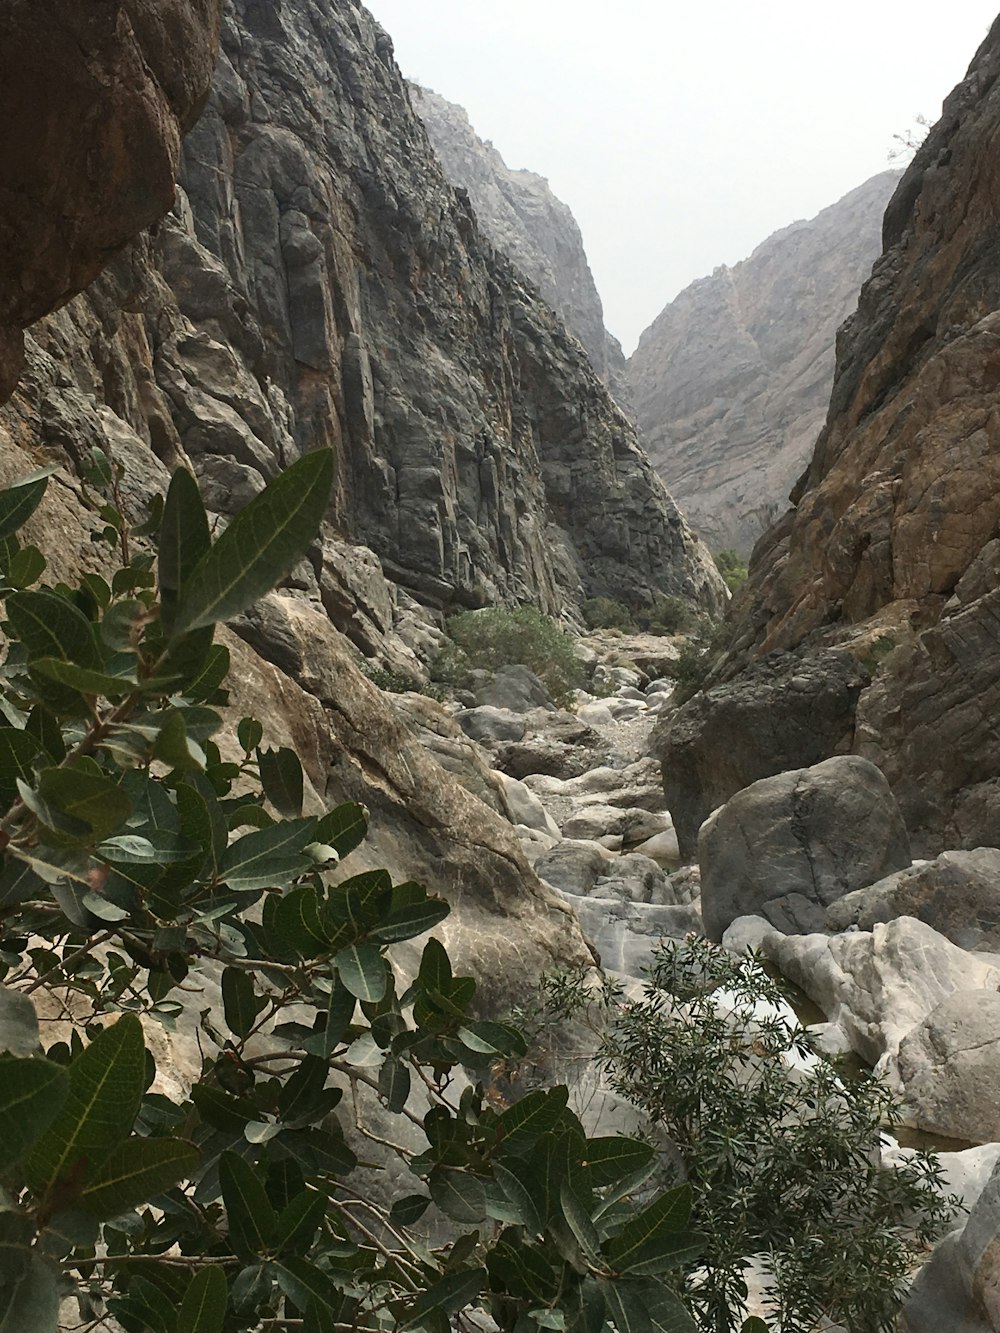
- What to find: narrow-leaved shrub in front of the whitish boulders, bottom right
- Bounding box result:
[600,940,955,1333]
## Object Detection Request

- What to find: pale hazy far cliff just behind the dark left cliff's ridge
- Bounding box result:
[409,84,625,405]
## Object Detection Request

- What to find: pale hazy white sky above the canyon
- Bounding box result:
[367,0,1000,352]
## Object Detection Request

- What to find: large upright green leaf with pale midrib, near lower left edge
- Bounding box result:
[27,1013,145,1193]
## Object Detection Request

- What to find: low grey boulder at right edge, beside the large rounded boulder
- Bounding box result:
[827,846,1000,952]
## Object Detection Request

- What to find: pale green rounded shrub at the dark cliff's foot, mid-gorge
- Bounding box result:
[445,607,587,705]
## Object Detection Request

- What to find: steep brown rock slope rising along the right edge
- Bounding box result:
[660,20,1000,852]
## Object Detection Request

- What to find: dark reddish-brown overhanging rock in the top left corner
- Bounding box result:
[0,0,223,401]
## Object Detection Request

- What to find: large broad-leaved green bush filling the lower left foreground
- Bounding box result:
[0,451,746,1333]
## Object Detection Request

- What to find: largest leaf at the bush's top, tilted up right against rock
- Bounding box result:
[171,449,333,636]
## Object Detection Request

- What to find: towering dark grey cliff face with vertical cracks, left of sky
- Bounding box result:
[162,0,720,612]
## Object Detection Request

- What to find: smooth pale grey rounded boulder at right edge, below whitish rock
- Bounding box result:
[899,989,1000,1142]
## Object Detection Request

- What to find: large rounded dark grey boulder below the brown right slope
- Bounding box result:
[699,754,911,941]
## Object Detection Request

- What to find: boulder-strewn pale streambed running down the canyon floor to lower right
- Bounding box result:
[403,626,1000,1333]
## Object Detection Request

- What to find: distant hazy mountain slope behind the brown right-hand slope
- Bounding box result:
[627,171,900,553]
